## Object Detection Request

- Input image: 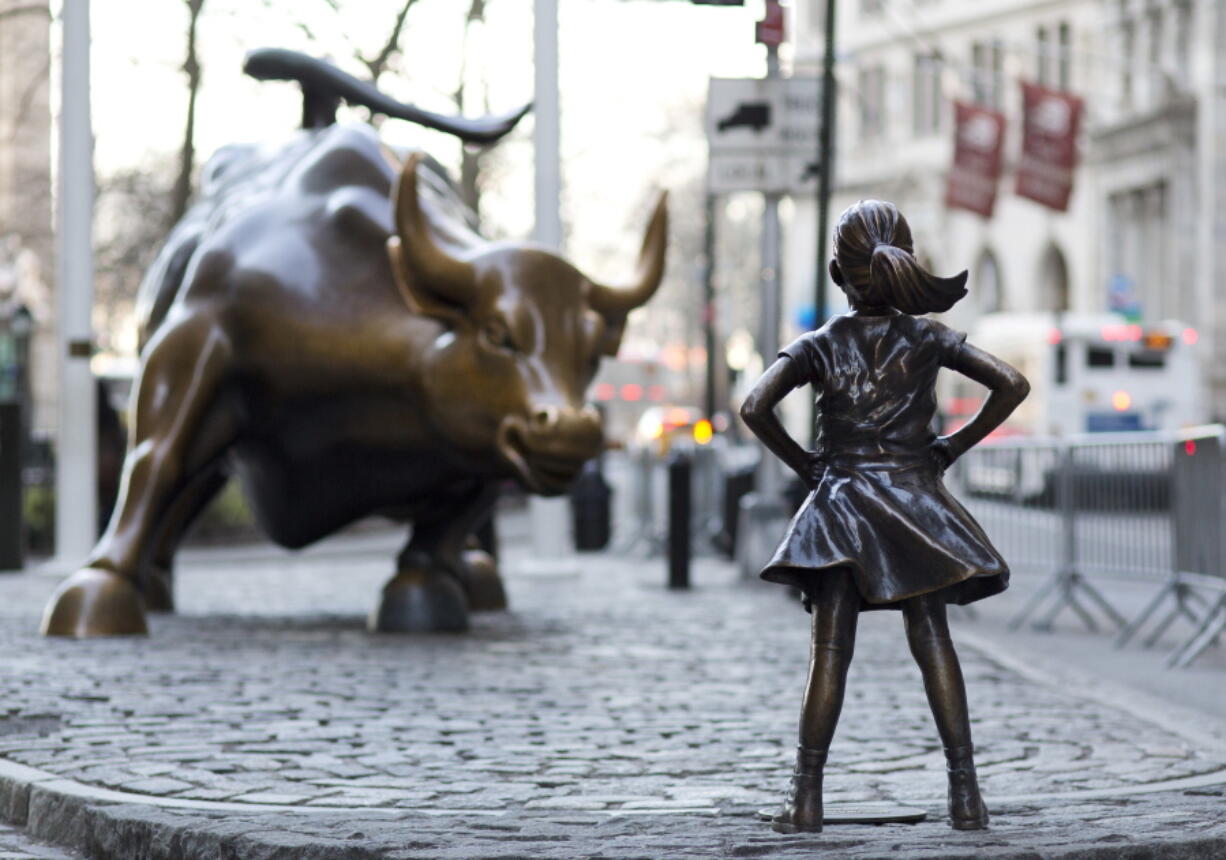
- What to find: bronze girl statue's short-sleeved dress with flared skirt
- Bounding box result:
[761,313,1009,610]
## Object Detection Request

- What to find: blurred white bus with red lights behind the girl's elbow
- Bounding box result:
[940,313,1209,438]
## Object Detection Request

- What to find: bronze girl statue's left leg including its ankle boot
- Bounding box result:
[774,570,859,833]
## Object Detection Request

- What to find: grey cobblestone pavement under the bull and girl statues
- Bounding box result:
[0,522,1226,860]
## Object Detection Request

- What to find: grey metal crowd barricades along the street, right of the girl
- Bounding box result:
[950,426,1226,665]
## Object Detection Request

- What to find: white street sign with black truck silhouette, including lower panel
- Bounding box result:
[706,77,820,194]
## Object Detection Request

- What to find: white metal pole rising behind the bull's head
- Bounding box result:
[528,0,573,559]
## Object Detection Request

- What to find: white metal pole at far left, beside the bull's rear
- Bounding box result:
[55,0,98,567]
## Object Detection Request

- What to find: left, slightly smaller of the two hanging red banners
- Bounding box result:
[945,102,1004,218]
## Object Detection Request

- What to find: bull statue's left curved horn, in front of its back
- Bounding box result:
[392,152,477,304]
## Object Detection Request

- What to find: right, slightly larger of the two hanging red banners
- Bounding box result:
[1018,81,1083,212]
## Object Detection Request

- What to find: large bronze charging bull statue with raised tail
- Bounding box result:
[43,52,667,637]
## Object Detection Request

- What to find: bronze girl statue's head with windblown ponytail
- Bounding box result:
[834,200,966,314]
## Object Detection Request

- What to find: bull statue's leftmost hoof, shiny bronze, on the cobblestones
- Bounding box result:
[42,567,148,639]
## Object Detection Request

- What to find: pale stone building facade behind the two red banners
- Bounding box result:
[788,0,1226,420]
